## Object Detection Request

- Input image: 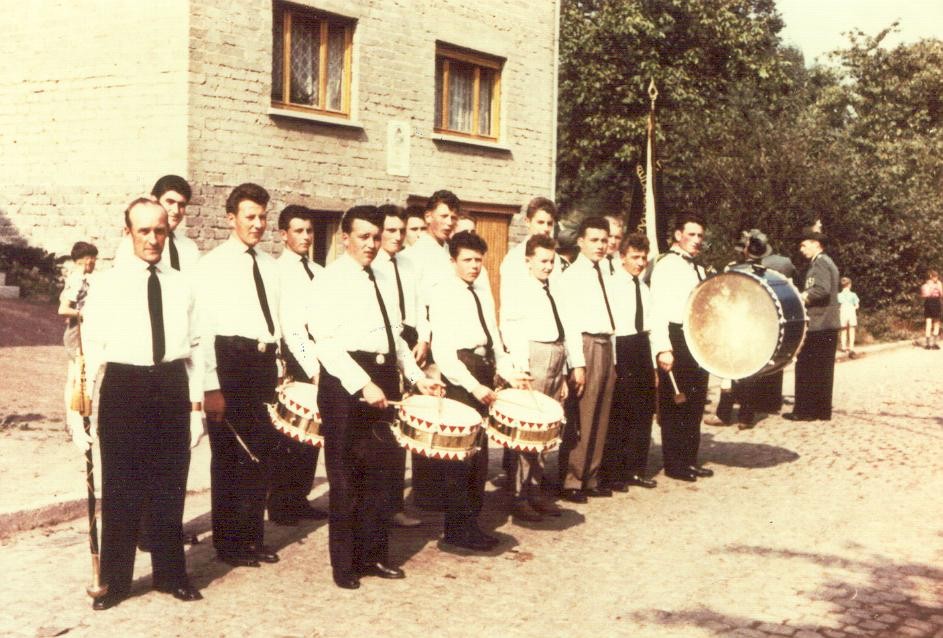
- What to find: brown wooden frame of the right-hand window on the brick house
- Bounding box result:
[433,43,504,142]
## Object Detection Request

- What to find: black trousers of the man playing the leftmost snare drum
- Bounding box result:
[209,337,282,554]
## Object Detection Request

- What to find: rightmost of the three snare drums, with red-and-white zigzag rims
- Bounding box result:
[488,388,563,453]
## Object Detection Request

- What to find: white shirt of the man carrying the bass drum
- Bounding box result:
[651,246,705,355]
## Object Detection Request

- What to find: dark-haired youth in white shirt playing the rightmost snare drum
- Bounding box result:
[430,232,525,551]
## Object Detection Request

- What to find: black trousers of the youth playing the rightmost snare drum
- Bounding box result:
[434,350,495,540]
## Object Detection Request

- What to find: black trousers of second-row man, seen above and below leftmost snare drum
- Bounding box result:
[268,343,320,517]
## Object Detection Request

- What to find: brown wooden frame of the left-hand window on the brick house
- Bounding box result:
[272,1,355,119]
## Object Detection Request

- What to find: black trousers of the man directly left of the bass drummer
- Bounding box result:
[600,334,655,482]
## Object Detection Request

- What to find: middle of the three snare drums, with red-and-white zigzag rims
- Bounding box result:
[392,394,481,461]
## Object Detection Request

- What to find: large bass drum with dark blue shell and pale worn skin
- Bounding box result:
[684,266,808,380]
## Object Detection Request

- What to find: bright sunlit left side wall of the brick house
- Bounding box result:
[0,0,188,257]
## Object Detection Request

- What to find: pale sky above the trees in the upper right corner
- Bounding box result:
[776,0,943,64]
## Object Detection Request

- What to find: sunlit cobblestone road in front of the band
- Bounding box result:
[0,348,943,638]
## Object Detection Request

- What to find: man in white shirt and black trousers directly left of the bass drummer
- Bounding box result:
[599,233,657,492]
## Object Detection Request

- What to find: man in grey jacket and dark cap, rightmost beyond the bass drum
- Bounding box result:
[783,231,841,421]
